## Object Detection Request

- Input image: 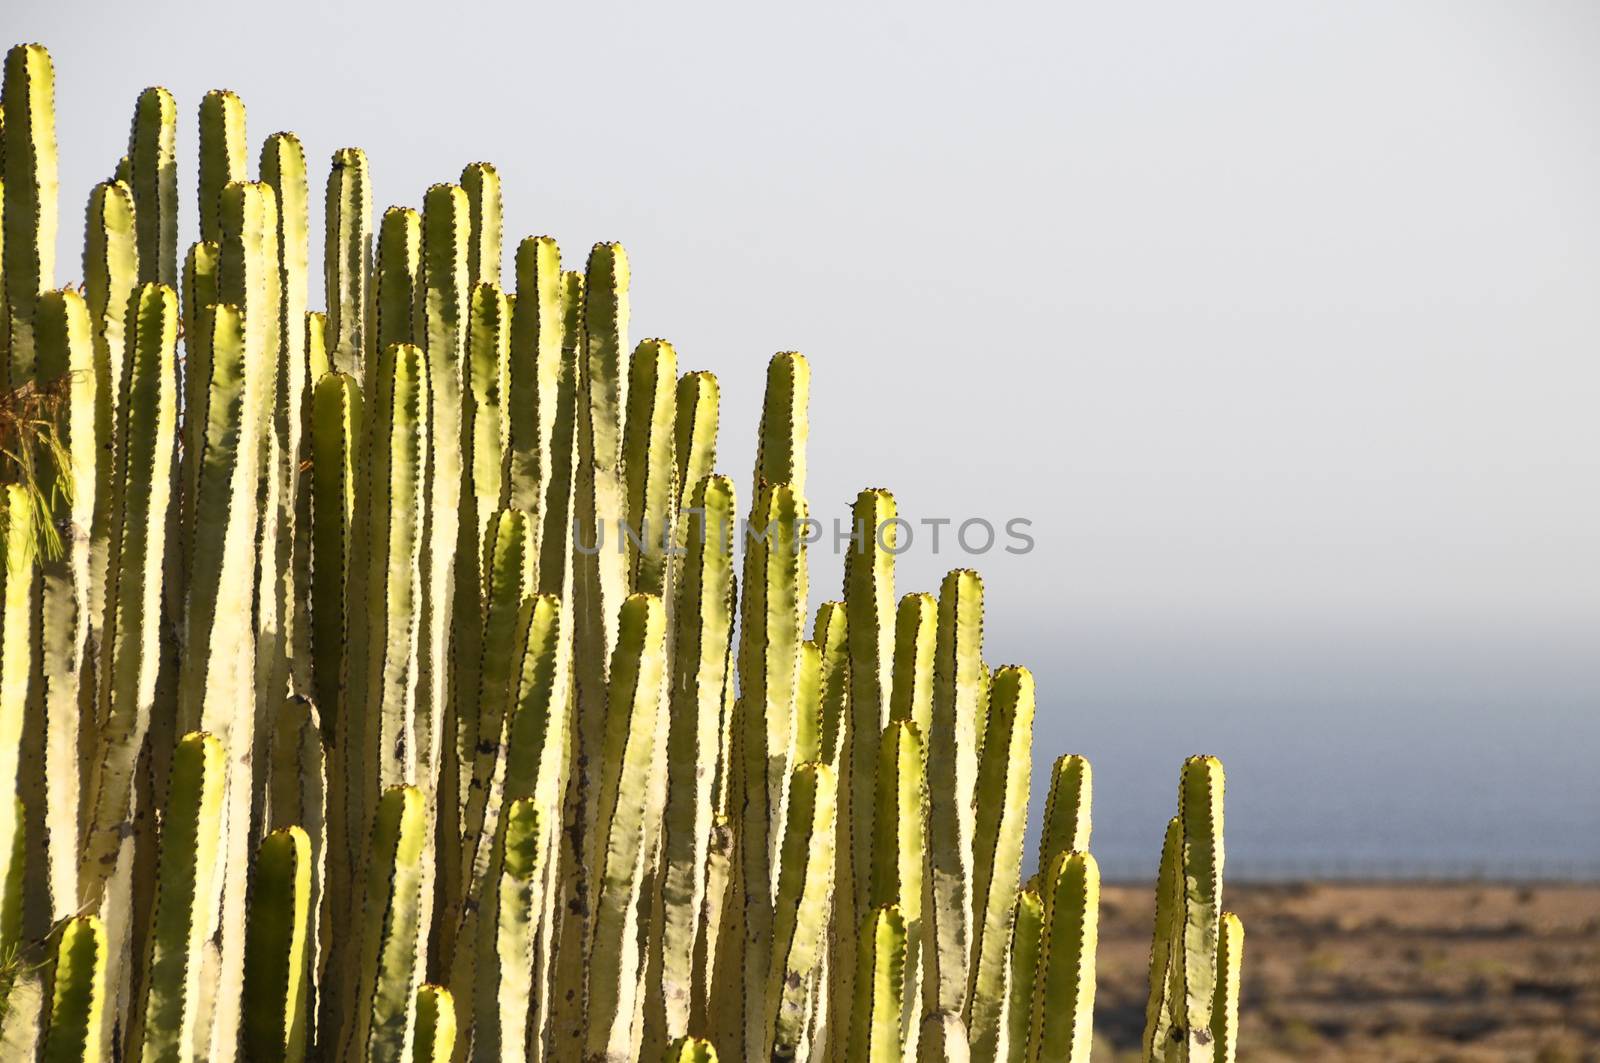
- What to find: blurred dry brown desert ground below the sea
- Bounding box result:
[1094,884,1600,1063]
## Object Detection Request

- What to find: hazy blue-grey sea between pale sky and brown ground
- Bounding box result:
[1026,637,1600,880]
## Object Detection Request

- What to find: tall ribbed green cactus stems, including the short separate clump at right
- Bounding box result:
[0,45,1242,1063]
